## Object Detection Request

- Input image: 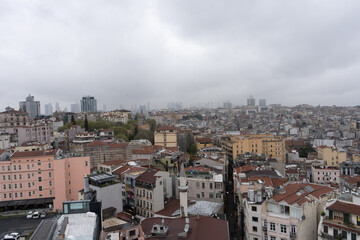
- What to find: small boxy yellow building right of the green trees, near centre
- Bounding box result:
[154,126,178,147]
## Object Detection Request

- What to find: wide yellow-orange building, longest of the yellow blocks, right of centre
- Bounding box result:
[222,134,285,162]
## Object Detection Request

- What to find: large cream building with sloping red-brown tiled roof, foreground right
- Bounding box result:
[261,183,335,240]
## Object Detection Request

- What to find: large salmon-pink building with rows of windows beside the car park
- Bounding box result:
[0,150,90,211]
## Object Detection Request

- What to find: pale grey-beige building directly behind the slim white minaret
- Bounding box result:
[175,166,224,202]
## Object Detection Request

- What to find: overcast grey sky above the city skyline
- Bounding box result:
[0,0,360,110]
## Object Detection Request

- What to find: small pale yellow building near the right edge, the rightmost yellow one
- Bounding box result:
[317,146,346,167]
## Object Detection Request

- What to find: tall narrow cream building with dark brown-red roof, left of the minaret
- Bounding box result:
[135,169,172,217]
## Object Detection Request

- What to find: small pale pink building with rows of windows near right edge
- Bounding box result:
[311,166,340,184]
